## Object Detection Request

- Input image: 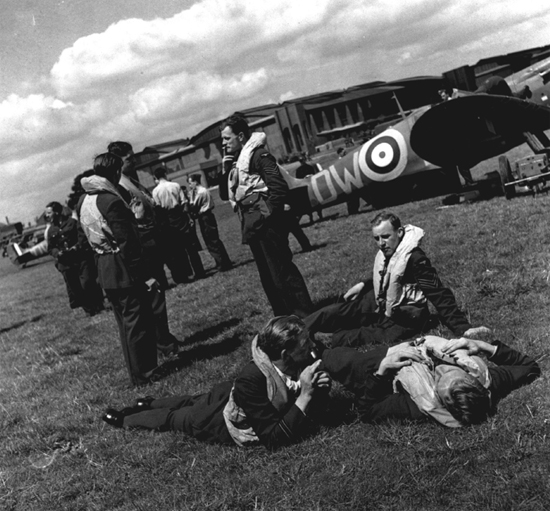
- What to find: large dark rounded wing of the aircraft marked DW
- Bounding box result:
[410,94,550,167]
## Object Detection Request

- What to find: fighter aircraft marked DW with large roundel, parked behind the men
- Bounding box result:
[283,82,550,212]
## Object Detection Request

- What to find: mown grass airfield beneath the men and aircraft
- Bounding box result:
[0,145,550,511]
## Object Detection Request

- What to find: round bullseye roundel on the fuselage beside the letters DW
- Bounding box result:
[359,129,407,181]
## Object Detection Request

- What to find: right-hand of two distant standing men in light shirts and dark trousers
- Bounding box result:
[187,174,233,271]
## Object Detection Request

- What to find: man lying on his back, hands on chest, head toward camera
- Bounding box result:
[323,336,540,427]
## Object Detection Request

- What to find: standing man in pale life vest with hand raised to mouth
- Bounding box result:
[220,114,313,317]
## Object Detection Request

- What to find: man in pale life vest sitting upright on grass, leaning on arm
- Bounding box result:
[305,213,489,347]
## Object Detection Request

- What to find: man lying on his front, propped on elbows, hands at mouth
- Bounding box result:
[103,316,331,449]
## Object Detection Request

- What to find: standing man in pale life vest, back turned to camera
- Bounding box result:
[78,153,164,386]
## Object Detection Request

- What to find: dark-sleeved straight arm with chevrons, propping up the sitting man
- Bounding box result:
[409,249,472,335]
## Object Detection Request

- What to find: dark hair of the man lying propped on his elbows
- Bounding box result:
[258,316,309,360]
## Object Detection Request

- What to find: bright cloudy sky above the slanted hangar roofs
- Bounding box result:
[0,0,550,222]
